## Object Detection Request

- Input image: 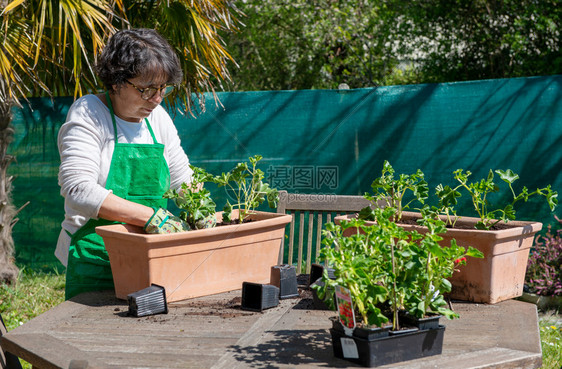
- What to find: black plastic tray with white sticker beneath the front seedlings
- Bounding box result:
[330,325,445,367]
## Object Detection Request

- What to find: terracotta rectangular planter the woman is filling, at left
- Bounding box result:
[96,212,291,302]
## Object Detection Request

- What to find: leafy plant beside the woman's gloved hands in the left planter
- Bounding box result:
[164,165,216,229]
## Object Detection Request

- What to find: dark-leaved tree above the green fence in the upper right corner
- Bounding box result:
[395,0,562,82]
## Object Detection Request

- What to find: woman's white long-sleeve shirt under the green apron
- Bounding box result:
[55,95,192,266]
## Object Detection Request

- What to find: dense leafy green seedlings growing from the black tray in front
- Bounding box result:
[315,207,483,330]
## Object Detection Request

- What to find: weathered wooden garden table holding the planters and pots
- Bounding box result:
[0,291,542,369]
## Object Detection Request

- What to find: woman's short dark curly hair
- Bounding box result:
[96,28,183,91]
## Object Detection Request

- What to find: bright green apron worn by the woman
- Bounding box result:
[65,92,170,300]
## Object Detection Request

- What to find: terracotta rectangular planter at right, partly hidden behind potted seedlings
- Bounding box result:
[335,212,542,304]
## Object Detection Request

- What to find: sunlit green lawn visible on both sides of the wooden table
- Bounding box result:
[0,269,562,369]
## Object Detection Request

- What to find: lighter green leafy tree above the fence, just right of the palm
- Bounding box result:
[220,0,397,90]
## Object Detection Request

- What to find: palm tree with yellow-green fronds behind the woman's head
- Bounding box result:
[0,0,237,281]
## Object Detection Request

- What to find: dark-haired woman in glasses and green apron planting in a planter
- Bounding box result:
[55,29,192,299]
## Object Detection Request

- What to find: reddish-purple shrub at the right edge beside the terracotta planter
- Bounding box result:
[525,218,562,296]
